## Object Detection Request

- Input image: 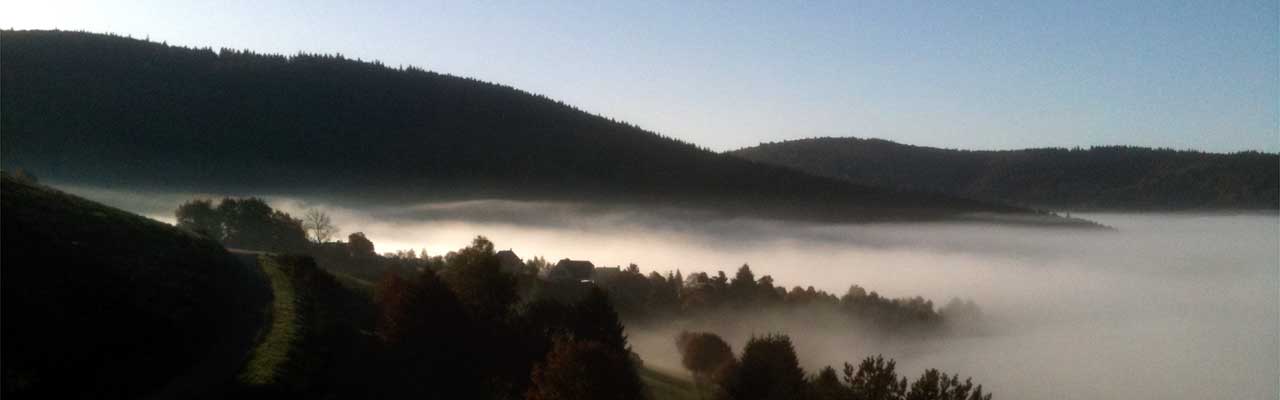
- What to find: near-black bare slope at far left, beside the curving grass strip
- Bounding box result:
[0,174,269,399]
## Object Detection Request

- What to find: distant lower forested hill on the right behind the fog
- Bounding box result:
[730,137,1280,210]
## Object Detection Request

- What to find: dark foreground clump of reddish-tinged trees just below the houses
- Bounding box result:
[375,237,643,399]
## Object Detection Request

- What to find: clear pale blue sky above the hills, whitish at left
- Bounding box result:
[0,0,1280,151]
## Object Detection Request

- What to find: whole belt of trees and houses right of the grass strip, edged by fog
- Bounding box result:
[167,197,984,400]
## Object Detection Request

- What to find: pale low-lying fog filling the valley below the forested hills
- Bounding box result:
[70,187,1280,399]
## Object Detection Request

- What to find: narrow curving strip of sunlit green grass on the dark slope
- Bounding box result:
[239,255,303,386]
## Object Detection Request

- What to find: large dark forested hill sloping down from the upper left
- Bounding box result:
[0,31,1090,223]
